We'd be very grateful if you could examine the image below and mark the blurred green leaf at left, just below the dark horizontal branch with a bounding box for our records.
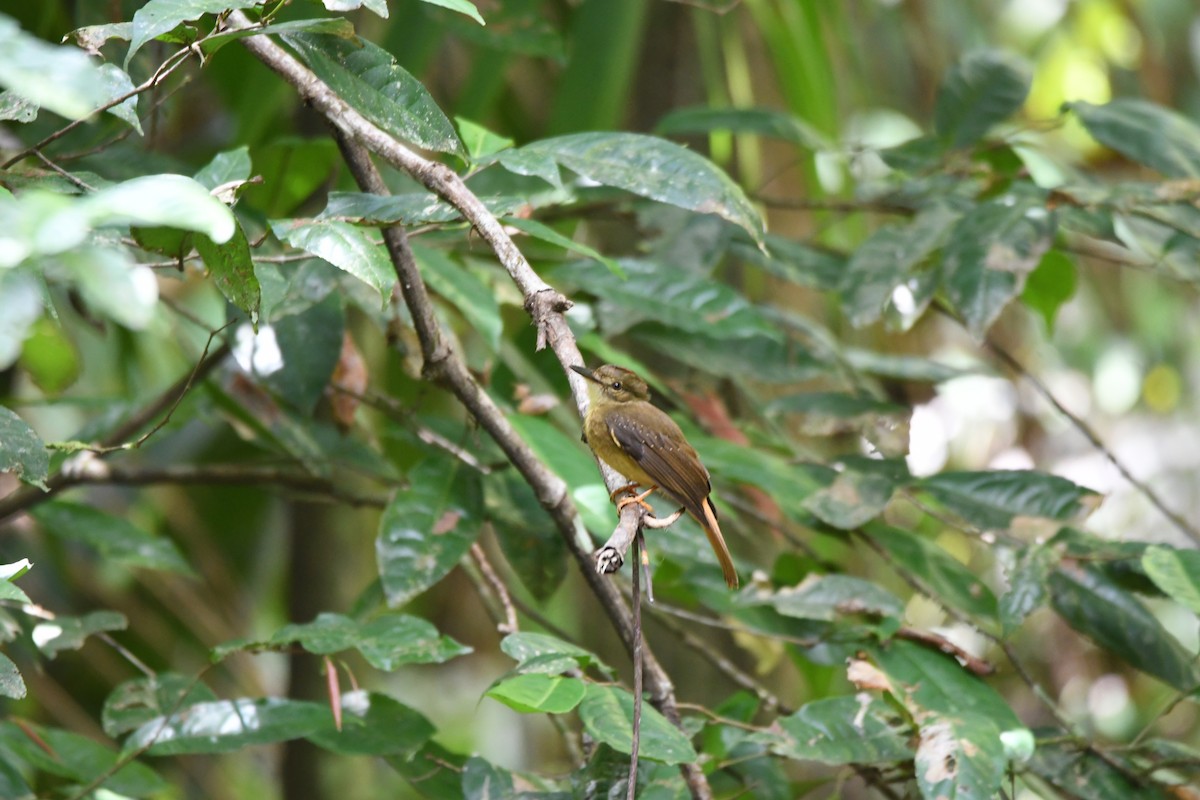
[30,500,193,575]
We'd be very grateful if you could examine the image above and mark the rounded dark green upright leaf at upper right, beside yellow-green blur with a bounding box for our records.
[934,50,1031,148]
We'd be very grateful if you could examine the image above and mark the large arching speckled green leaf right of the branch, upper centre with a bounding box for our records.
[499,133,766,243]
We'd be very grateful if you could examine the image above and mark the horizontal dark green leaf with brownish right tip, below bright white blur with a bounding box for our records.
[917,469,1099,529]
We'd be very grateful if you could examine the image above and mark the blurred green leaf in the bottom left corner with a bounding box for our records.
[0,722,170,798]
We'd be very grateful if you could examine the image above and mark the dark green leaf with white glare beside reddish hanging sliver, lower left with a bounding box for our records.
[308,690,437,756]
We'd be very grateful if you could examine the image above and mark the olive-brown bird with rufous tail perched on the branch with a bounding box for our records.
[571,363,738,589]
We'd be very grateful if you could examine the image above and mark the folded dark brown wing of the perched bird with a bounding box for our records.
[605,414,712,517]
